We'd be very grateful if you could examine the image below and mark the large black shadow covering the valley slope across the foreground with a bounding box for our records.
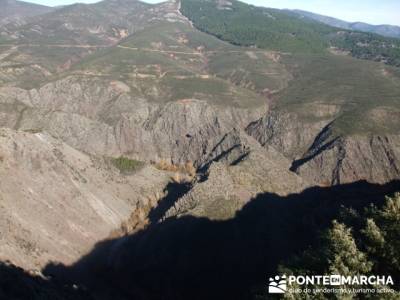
[9,181,400,300]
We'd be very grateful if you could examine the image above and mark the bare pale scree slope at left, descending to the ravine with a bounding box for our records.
[0,129,170,269]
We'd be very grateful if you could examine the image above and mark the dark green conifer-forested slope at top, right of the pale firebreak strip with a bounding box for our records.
[181,0,335,53]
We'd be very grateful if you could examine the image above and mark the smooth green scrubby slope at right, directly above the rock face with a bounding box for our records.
[275,55,400,135]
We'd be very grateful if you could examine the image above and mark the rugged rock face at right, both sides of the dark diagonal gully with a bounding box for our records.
[246,112,400,185]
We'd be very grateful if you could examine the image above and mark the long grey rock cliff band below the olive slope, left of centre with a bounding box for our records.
[0,77,265,164]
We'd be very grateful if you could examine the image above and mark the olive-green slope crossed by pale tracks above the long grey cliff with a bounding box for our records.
[71,22,290,107]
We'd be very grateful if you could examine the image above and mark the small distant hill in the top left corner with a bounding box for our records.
[0,0,53,25]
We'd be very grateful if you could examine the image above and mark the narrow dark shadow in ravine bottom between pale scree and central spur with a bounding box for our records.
[149,182,192,224]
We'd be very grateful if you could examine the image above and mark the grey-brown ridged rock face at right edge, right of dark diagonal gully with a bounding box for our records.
[292,131,400,185]
